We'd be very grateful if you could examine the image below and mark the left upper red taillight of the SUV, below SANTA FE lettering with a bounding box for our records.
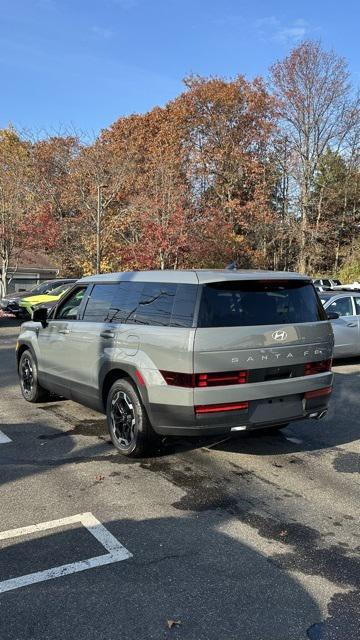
[160,371,248,388]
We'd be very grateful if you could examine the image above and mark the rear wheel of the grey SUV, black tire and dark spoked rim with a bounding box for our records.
[106,379,157,458]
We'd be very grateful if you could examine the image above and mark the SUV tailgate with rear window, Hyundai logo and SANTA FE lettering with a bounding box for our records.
[194,278,333,416]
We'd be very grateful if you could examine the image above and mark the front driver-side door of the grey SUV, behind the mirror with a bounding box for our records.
[37,285,87,397]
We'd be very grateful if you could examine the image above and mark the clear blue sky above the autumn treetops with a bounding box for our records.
[0,0,360,135]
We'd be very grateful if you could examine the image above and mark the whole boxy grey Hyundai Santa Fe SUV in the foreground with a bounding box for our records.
[17,270,333,456]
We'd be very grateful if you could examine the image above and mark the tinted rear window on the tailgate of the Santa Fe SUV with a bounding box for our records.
[198,280,327,327]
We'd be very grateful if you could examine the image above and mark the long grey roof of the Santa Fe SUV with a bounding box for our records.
[78,269,311,284]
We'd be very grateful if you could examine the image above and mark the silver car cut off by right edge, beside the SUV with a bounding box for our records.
[319,291,360,358]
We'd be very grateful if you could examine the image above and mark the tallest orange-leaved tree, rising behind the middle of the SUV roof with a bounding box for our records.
[179,76,276,266]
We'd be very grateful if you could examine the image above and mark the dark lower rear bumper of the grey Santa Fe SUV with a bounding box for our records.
[149,394,330,436]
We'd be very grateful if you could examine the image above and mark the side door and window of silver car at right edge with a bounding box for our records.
[326,295,359,358]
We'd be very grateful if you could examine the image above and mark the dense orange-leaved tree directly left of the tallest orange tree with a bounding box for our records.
[103,105,191,269]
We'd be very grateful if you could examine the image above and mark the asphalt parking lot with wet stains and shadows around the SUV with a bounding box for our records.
[0,320,360,640]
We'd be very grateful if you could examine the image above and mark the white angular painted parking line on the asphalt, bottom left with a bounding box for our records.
[0,513,132,593]
